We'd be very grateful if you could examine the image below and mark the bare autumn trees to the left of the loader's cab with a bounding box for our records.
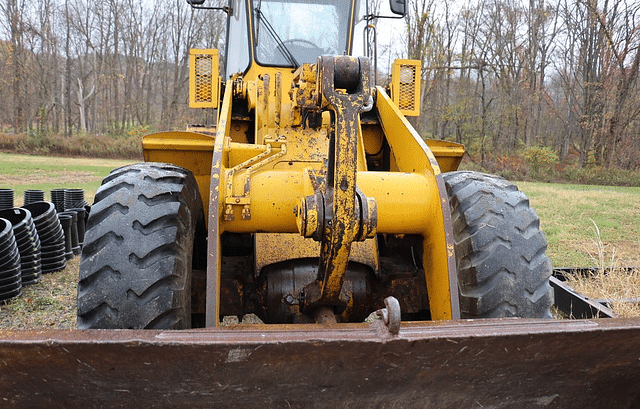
[0,0,225,135]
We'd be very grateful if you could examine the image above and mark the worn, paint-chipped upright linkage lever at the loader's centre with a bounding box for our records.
[312,55,377,304]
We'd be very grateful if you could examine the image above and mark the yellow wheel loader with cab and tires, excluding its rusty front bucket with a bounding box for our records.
[78,0,553,332]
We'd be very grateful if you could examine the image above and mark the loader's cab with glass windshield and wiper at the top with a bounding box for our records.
[188,0,405,78]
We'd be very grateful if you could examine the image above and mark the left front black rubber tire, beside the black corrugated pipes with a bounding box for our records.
[78,163,204,329]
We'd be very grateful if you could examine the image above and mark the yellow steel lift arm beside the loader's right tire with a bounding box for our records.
[376,87,459,320]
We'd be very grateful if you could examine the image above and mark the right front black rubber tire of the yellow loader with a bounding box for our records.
[443,171,553,318]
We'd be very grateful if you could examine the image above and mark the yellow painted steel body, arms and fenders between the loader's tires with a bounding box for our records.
[148,47,464,326]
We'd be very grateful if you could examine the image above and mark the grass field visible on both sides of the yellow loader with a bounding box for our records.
[0,153,640,329]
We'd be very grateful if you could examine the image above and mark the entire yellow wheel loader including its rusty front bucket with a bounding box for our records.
[0,0,640,408]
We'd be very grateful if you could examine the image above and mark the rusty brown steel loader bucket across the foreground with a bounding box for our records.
[0,319,640,408]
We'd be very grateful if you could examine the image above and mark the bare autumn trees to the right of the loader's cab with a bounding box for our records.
[405,0,640,169]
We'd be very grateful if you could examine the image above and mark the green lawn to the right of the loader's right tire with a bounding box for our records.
[517,182,640,267]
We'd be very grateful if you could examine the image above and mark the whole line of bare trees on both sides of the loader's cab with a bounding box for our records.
[0,0,640,169]
